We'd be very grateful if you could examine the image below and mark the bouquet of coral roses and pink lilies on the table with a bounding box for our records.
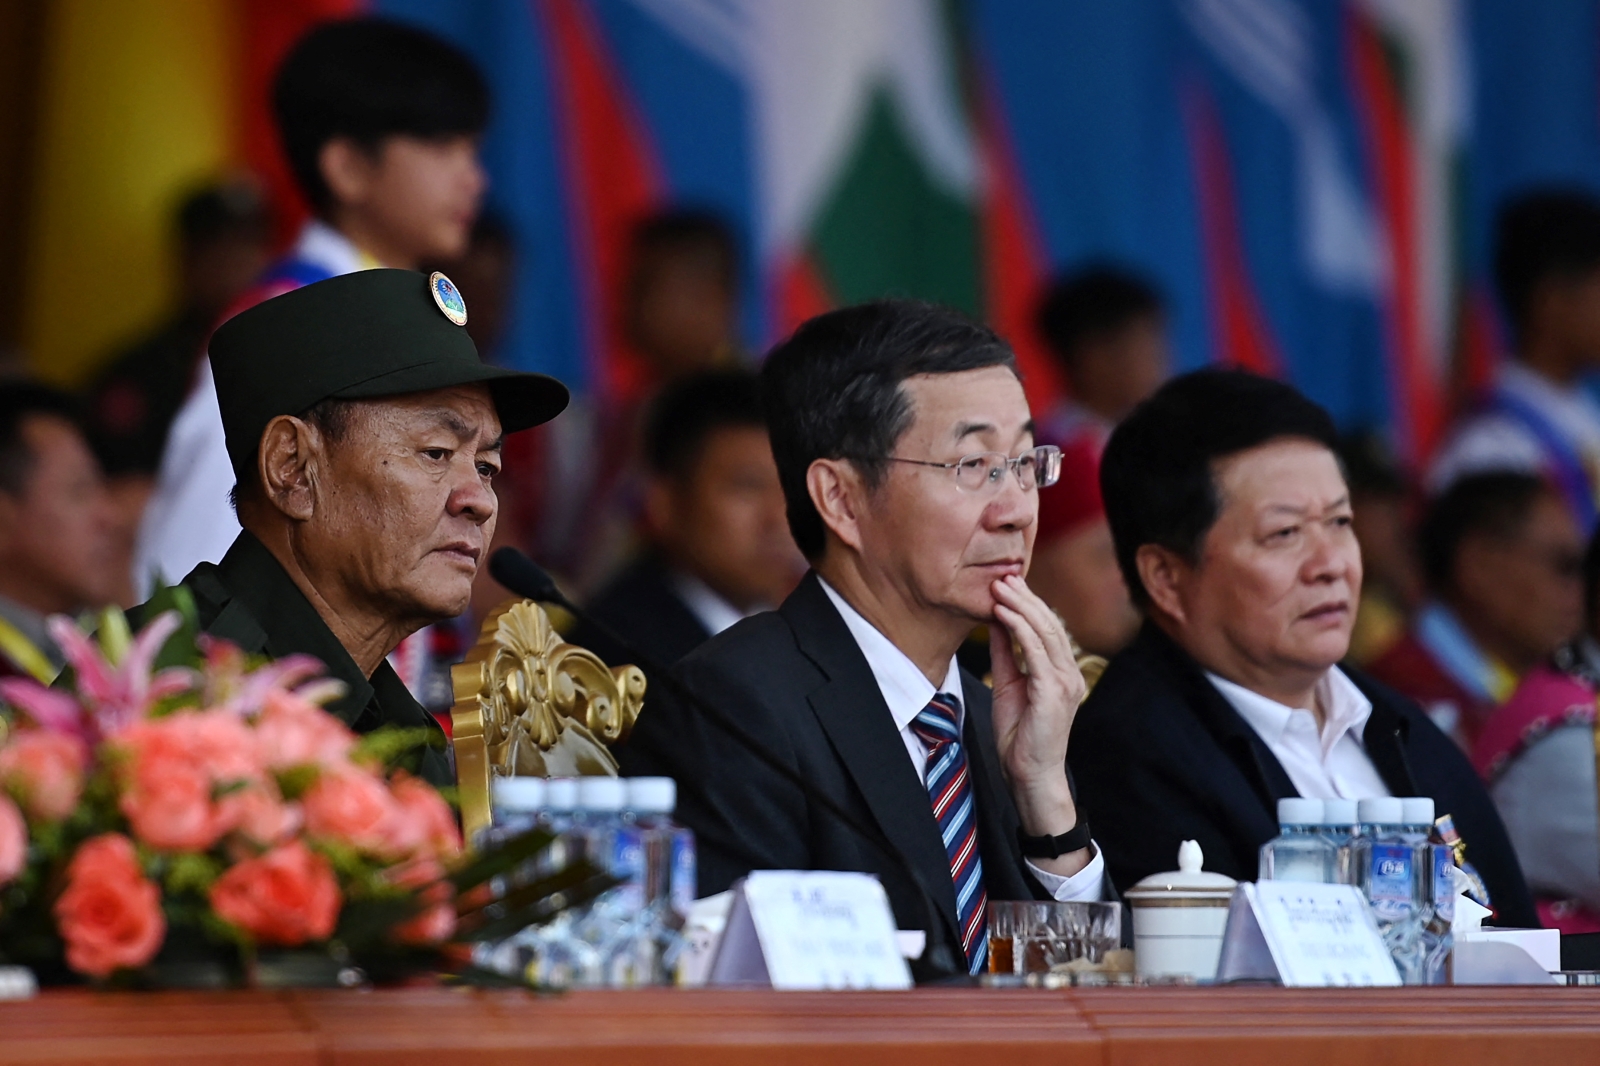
[0,595,474,981]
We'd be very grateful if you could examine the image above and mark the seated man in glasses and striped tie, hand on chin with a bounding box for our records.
[622,301,1104,973]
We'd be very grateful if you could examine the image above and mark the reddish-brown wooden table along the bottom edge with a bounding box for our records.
[0,988,1600,1066]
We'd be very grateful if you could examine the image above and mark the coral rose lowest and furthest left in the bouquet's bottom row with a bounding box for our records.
[54,832,166,978]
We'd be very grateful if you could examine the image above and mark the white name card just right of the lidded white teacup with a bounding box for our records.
[1216,880,1400,988]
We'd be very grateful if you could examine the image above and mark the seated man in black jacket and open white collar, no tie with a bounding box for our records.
[1069,370,1538,925]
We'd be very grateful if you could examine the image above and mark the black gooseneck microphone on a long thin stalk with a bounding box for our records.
[490,547,966,978]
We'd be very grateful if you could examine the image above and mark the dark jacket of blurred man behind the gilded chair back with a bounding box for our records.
[568,555,710,675]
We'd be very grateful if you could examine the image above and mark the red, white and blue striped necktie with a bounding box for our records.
[910,691,989,973]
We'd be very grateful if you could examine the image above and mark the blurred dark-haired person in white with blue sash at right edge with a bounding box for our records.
[1429,189,1600,536]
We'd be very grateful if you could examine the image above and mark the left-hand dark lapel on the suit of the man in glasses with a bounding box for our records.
[781,573,960,944]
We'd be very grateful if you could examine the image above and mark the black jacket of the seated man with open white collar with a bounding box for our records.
[1067,623,1539,927]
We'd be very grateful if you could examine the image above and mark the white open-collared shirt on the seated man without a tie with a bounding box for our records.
[1206,666,1389,800]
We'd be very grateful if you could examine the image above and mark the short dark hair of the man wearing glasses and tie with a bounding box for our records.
[762,299,1016,560]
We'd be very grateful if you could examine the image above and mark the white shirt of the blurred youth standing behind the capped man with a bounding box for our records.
[133,221,370,597]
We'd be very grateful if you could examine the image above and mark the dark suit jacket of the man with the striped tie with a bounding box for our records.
[621,573,1043,959]
